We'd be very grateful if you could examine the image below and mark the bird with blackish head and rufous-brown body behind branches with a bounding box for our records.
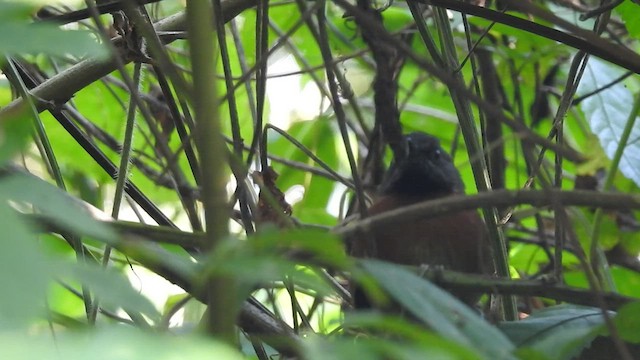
[349,132,494,309]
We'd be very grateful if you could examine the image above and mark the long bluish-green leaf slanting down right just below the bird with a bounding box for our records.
[362,260,515,359]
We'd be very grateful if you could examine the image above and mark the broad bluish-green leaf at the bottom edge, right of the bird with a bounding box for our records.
[500,305,604,360]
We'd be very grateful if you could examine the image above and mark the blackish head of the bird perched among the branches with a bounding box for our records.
[381,132,464,197]
